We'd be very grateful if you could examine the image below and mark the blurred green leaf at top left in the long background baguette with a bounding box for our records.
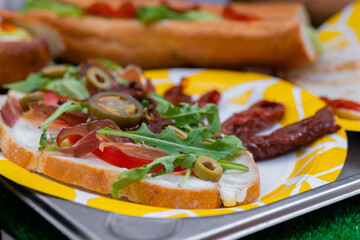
[22,0,84,17]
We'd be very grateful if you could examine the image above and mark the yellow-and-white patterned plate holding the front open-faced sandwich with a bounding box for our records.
[0,69,347,218]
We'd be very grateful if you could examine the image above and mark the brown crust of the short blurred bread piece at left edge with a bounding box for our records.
[0,38,50,85]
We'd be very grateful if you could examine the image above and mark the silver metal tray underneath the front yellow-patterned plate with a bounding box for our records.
[0,132,360,240]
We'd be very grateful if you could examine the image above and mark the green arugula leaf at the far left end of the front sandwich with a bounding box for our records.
[4,72,51,93]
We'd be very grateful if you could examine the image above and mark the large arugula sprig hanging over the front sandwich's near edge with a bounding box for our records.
[98,123,248,198]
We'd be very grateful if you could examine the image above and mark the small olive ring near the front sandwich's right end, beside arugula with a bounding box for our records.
[194,156,222,182]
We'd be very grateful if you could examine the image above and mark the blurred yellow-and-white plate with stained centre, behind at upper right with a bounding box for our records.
[287,1,360,131]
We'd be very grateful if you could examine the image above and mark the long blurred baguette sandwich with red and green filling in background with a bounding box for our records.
[21,0,319,69]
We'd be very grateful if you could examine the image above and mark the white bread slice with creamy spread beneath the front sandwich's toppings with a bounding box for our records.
[0,96,260,209]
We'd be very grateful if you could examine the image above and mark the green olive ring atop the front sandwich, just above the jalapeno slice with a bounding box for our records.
[86,67,111,90]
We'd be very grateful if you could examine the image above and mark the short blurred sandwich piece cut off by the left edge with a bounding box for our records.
[0,9,64,86]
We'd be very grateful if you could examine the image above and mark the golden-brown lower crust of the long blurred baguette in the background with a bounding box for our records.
[28,10,316,69]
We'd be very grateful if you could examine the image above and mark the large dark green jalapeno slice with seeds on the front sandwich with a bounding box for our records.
[89,92,144,128]
